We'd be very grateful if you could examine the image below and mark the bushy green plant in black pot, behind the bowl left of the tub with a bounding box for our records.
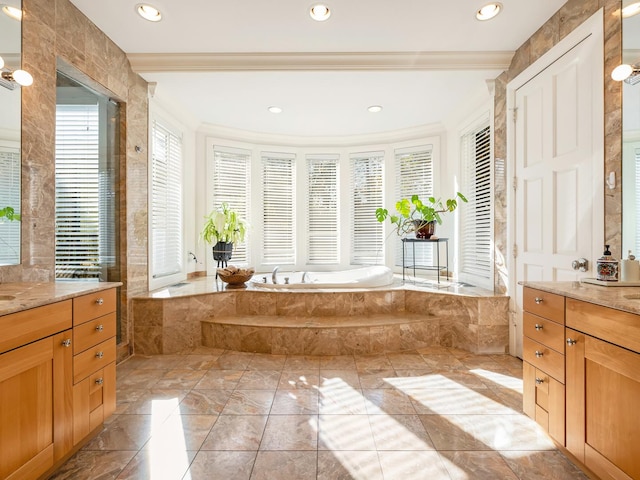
[200,202,247,266]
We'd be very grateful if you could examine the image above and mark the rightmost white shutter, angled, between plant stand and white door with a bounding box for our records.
[460,120,493,280]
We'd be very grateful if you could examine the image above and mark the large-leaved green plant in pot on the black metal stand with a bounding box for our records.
[376,192,467,238]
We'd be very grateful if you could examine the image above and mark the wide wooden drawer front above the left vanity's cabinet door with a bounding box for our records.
[0,300,71,353]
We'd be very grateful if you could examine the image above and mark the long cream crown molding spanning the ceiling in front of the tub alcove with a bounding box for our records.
[127,51,514,73]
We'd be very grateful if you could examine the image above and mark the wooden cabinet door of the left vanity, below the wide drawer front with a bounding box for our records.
[0,337,54,479]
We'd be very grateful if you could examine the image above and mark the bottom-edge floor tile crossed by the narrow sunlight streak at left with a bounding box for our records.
[117,448,196,480]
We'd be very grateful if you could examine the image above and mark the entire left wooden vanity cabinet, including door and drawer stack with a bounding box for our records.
[0,288,116,480]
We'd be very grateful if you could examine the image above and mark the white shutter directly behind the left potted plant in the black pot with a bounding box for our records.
[207,146,251,266]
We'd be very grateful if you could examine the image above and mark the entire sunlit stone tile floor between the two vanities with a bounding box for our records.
[51,347,586,480]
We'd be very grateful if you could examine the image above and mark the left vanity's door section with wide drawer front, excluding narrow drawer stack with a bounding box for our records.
[0,301,72,480]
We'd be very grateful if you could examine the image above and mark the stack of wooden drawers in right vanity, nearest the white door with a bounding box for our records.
[522,287,565,445]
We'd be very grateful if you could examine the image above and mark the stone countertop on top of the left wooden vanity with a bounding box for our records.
[0,282,122,315]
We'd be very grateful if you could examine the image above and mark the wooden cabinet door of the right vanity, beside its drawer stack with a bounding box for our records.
[567,330,640,479]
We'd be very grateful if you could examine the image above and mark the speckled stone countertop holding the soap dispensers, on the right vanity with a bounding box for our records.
[522,282,640,314]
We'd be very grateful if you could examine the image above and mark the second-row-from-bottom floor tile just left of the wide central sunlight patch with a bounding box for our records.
[260,415,318,451]
